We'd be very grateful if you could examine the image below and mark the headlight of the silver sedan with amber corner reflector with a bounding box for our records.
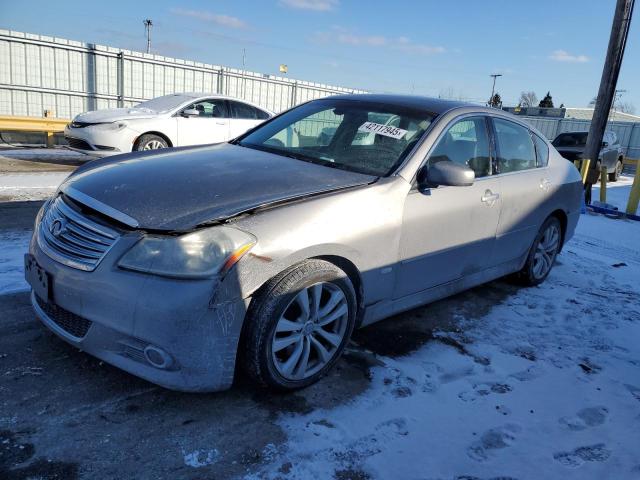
[118,226,256,278]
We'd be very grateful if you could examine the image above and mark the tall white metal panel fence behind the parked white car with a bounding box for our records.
[0,29,365,118]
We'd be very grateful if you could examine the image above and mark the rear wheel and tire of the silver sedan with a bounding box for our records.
[515,217,562,287]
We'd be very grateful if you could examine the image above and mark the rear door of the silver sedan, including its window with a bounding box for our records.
[492,117,557,264]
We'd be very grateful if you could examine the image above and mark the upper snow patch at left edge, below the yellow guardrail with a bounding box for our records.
[0,172,69,201]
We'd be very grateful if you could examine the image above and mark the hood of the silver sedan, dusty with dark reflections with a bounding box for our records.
[61,143,377,231]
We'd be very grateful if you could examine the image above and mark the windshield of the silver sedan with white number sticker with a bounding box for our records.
[236,99,434,176]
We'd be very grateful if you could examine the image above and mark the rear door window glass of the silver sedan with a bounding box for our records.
[493,118,537,173]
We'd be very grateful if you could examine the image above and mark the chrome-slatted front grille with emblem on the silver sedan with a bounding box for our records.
[37,196,120,271]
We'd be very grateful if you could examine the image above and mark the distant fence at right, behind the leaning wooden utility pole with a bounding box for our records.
[523,117,640,159]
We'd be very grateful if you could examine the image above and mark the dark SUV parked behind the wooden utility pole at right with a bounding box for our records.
[552,132,624,182]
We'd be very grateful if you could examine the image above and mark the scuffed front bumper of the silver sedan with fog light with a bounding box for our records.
[29,231,248,391]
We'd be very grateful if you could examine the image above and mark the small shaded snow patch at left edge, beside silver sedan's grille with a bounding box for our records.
[0,230,31,295]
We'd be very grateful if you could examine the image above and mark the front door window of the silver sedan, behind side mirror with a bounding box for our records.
[428,117,491,178]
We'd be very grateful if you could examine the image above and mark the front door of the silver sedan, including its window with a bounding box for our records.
[395,116,502,298]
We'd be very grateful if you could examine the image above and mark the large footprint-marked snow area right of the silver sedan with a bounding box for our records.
[251,215,640,480]
